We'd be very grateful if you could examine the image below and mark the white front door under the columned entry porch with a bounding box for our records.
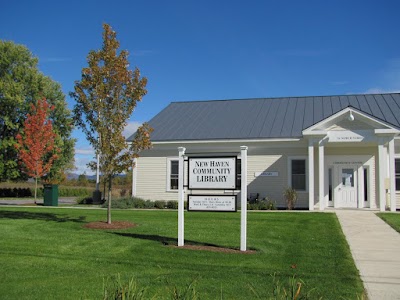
[337,165,358,208]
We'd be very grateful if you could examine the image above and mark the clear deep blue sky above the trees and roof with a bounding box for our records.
[0,0,400,173]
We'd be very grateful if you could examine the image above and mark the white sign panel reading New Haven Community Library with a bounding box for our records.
[189,157,236,190]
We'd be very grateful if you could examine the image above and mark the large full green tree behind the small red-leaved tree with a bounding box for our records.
[0,40,75,183]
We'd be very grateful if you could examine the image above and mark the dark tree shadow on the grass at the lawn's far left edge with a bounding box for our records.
[0,210,86,223]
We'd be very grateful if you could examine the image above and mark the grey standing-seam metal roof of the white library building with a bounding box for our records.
[128,93,400,141]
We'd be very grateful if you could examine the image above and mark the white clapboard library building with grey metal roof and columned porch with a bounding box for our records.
[128,93,400,211]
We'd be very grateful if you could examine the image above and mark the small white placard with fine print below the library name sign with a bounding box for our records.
[188,195,236,212]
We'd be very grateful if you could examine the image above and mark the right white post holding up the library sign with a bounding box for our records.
[240,146,248,251]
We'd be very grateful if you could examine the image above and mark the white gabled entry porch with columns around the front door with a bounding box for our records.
[303,108,399,211]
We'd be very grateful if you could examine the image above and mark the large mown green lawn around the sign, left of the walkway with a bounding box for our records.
[0,207,363,299]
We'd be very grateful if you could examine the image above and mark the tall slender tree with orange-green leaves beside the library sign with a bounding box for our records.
[70,24,152,224]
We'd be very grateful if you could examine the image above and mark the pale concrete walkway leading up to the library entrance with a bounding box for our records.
[336,210,400,300]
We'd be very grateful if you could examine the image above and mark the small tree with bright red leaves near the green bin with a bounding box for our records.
[15,99,60,203]
